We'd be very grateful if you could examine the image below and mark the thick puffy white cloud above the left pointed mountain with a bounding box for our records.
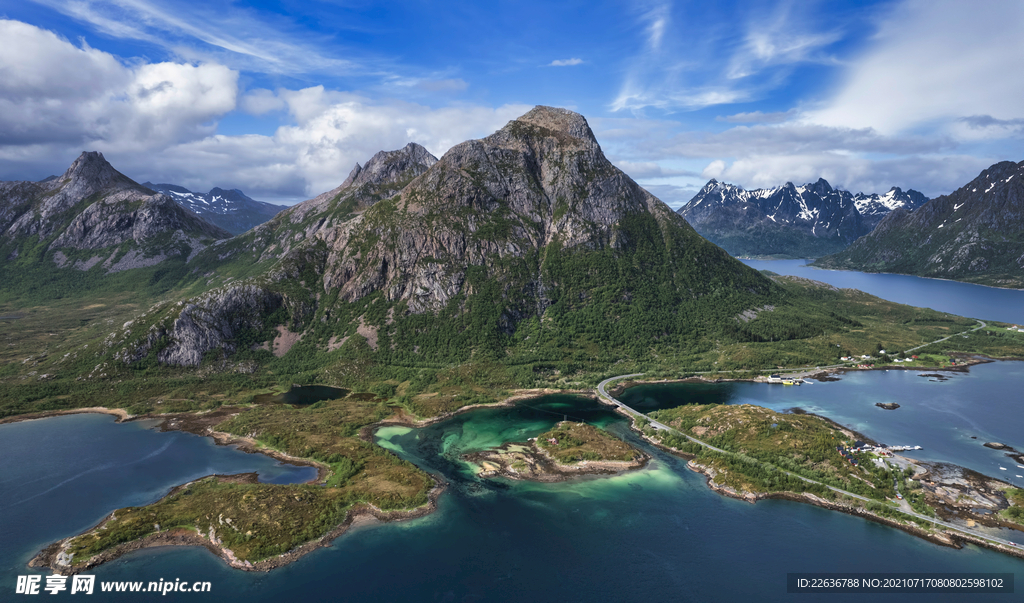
[0,20,238,153]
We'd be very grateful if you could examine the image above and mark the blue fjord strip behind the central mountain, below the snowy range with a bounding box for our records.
[742,260,1024,322]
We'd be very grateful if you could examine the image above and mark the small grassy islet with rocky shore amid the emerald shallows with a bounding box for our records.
[463,421,649,481]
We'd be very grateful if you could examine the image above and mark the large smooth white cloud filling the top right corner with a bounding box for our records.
[806,0,1024,134]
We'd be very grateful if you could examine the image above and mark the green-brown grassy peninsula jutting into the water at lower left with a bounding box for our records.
[61,394,434,561]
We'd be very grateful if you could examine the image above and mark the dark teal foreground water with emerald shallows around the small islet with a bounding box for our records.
[0,393,1024,602]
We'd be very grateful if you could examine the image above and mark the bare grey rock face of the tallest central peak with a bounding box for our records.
[318,106,686,312]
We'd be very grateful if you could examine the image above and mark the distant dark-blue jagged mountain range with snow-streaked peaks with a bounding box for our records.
[679,178,927,257]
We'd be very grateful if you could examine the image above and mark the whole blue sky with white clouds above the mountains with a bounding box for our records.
[0,0,1024,207]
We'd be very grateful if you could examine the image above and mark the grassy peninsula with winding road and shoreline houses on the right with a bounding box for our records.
[635,404,1024,547]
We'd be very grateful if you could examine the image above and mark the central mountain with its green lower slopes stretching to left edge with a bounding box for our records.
[0,106,1015,417]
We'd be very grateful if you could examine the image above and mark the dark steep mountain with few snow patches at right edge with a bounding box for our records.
[815,162,1024,288]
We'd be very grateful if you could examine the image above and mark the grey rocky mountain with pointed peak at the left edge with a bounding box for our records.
[0,153,230,286]
